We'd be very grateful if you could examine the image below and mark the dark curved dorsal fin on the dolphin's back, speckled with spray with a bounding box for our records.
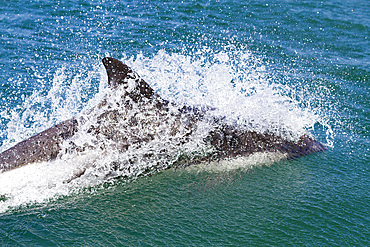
[102,57,160,100]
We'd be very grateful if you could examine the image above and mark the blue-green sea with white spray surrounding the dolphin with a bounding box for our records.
[0,0,370,246]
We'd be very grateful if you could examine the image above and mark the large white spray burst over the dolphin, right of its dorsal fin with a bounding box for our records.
[122,48,321,138]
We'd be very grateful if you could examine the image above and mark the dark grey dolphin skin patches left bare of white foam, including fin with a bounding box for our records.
[0,57,326,173]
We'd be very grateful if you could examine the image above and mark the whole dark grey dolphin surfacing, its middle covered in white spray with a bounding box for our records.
[0,57,326,172]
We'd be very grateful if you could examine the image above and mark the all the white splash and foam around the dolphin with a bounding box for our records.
[0,47,330,212]
